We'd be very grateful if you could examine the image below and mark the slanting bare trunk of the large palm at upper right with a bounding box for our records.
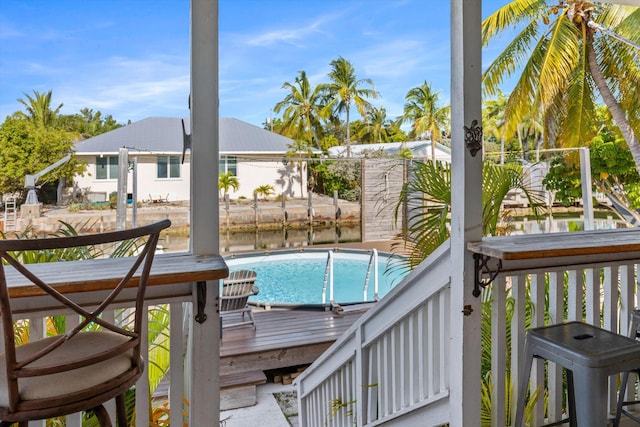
[587,42,640,173]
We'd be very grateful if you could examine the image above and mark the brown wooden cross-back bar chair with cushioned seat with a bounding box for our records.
[0,220,171,427]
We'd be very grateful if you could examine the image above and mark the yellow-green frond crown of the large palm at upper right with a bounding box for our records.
[482,0,640,171]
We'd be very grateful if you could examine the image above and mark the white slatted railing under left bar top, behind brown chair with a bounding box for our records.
[5,298,191,427]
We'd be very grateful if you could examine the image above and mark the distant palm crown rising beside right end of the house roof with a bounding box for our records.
[274,71,324,149]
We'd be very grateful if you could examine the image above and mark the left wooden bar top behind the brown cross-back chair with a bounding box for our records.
[5,253,229,298]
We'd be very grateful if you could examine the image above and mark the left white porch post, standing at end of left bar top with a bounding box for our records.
[190,0,220,426]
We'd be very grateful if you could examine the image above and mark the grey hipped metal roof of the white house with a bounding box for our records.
[75,117,293,155]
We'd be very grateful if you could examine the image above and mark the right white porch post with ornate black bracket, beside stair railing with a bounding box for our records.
[450,0,482,427]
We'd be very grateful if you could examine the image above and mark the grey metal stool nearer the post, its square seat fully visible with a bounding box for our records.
[515,322,640,427]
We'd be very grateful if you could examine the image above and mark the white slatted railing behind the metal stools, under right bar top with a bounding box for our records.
[483,260,640,426]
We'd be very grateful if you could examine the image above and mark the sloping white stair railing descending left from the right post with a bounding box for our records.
[296,244,450,427]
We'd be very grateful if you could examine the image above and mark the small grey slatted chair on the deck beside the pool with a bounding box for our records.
[220,270,259,336]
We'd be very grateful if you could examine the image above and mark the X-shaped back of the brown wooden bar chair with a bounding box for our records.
[0,220,171,412]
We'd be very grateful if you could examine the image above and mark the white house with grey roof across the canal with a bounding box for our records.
[75,117,306,201]
